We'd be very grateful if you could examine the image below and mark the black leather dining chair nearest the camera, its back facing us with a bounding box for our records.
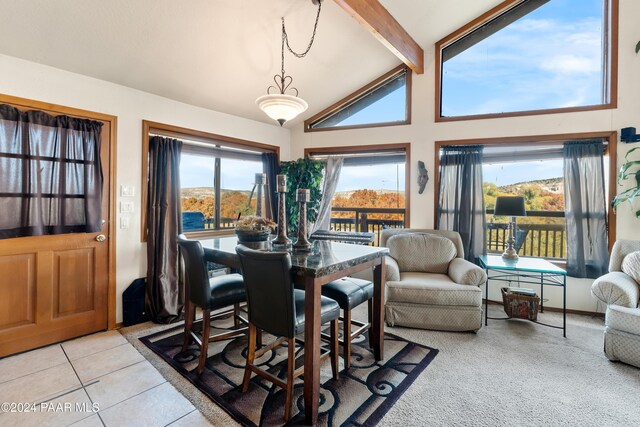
[236,245,340,421]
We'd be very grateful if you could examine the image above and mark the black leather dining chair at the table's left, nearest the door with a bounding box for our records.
[178,234,248,375]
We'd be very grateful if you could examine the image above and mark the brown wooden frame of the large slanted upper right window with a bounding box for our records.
[434,0,619,122]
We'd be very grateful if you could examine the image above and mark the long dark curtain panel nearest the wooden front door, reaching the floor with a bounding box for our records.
[146,136,184,323]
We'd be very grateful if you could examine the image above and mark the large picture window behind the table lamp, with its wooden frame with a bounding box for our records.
[436,132,617,262]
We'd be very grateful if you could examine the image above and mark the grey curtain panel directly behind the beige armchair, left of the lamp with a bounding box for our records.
[437,145,486,262]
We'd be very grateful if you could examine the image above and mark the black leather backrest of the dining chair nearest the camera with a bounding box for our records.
[236,245,296,338]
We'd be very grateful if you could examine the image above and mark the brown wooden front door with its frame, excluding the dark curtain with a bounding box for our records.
[0,96,115,357]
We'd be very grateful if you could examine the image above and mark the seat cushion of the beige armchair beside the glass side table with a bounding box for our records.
[386,272,482,307]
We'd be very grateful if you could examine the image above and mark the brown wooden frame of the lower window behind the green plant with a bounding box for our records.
[304,142,411,228]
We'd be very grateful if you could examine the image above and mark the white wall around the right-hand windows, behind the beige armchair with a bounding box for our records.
[291,0,640,311]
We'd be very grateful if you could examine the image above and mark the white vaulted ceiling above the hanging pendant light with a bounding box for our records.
[0,0,500,126]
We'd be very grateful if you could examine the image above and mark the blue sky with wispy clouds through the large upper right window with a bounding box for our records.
[442,0,602,116]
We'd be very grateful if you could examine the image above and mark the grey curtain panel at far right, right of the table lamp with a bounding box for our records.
[563,141,609,279]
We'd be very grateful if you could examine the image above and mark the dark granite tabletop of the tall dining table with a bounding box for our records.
[198,236,389,277]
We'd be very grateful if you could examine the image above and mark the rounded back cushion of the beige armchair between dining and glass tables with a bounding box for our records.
[387,233,458,274]
